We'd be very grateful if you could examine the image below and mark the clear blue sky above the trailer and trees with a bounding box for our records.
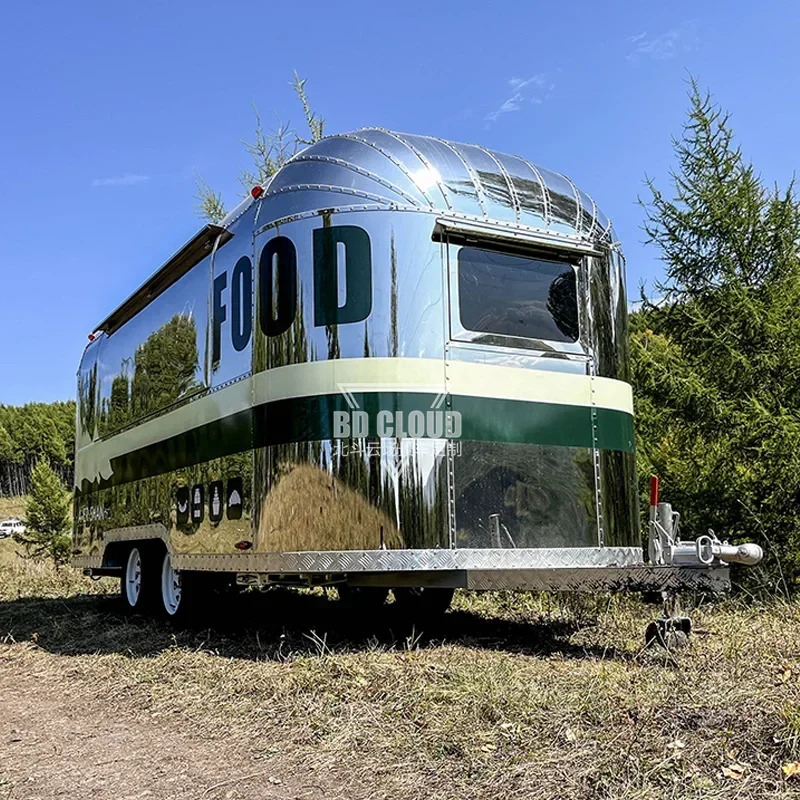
[0,0,800,404]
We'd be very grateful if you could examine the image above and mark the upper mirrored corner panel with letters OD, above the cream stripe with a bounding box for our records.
[253,209,445,371]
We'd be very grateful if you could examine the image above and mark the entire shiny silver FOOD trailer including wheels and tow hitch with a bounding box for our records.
[73,128,760,614]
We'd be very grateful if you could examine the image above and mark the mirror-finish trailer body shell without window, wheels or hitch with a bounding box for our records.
[76,129,638,555]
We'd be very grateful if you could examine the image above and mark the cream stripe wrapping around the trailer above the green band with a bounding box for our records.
[75,357,633,486]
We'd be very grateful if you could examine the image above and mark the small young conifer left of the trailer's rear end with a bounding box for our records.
[15,458,71,568]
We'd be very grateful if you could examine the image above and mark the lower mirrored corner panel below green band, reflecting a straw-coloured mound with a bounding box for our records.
[255,434,448,552]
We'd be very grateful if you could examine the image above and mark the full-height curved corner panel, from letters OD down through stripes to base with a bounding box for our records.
[253,209,449,552]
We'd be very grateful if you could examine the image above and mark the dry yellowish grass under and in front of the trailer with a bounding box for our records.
[0,543,800,800]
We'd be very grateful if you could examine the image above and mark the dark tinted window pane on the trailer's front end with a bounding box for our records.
[458,247,578,342]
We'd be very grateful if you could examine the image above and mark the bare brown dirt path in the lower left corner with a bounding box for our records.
[0,657,324,800]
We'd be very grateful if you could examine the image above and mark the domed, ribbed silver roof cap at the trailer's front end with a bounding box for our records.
[265,128,611,242]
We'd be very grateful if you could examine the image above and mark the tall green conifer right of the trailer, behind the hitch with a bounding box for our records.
[631,82,800,583]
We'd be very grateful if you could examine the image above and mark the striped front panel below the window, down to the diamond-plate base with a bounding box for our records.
[446,354,598,547]
